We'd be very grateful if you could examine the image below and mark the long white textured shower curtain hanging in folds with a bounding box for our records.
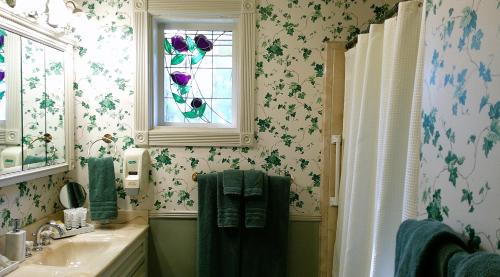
[333,1,423,277]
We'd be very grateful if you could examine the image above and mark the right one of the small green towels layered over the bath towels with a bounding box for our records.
[244,170,268,228]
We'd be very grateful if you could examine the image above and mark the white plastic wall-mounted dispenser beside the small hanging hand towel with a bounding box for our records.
[123,148,150,196]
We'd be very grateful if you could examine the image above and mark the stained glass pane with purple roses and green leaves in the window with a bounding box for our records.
[163,29,235,126]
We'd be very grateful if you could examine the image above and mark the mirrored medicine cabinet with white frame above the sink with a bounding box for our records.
[0,8,73,187]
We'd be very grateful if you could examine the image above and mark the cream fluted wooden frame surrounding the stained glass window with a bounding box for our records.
[133,0,256,147]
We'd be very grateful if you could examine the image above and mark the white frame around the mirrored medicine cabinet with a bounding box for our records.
[0,7,75,187]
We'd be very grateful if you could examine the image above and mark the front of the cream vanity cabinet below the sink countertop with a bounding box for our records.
[99,230,148,277]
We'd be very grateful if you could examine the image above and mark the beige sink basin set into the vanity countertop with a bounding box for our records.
[33,241,112,268]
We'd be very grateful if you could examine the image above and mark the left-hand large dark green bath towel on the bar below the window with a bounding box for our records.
[197,173,241,277]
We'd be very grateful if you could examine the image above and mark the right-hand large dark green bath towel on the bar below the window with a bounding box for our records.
[241,176,290,277]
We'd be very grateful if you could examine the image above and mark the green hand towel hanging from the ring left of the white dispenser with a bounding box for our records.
[88,157,118,220]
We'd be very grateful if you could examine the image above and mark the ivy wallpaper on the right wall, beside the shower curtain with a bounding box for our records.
[419,0,500,253]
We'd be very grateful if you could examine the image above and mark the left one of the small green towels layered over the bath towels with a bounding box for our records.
[217,172,241,228]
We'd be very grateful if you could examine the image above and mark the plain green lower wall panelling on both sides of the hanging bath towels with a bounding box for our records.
[148,218,319,277]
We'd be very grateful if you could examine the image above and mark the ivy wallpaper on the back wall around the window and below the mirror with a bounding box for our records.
[1,0,397,231]
